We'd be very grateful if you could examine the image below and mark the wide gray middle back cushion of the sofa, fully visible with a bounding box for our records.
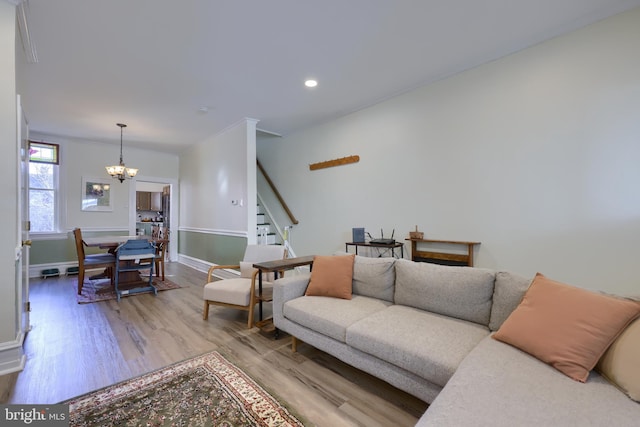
[394,259,495,326]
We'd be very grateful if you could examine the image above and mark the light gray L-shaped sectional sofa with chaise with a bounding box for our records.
[273,256,640,426]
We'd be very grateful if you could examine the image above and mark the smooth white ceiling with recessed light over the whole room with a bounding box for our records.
[17,0,640,153]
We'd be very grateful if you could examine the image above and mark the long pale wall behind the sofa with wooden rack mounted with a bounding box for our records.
[258,9,640,294]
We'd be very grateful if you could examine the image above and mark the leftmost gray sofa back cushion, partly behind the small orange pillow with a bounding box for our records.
[353,255,396,302]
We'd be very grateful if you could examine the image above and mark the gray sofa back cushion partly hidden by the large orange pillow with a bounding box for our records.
[489,271,531,331]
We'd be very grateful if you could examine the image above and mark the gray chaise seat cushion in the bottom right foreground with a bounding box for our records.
[417,338,640,427]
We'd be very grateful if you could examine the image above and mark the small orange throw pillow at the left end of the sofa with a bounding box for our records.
[305,254,355,299]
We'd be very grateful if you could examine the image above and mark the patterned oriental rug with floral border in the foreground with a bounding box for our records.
[62,351,304,427]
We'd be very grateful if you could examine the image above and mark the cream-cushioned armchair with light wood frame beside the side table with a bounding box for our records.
[202,245,286,329]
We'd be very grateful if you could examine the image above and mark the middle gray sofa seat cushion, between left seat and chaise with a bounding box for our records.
[347,305,489,386]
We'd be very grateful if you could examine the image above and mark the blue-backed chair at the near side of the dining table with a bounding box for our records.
[115,239,158,301]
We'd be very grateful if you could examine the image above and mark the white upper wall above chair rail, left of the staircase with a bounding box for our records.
[180,119,256,237]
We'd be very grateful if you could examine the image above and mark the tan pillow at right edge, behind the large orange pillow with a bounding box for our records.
[596,319,640,402]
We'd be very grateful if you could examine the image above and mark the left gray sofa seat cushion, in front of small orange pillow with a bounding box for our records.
[283,295,391,342]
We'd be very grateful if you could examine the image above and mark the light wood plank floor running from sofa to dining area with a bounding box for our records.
[8,263,427,427]
